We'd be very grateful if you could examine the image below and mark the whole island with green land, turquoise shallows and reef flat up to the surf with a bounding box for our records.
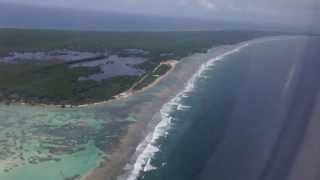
[0,29,284,180]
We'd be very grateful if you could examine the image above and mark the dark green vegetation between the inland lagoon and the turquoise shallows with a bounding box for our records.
[0,63,137,104]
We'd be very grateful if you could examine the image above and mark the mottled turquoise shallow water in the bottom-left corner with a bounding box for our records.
[0,105,112,180]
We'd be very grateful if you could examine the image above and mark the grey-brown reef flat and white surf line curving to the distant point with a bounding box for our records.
[83,36,304,180]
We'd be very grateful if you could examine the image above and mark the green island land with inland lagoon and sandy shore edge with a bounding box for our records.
[0,29,272,107]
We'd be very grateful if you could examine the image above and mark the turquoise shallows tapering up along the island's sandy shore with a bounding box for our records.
[0,40,231,180]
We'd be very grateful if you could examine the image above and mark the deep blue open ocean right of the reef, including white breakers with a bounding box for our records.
[127,37,320,180]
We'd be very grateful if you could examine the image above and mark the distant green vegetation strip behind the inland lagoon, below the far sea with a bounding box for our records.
[0,29,276,57]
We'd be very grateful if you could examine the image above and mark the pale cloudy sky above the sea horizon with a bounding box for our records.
[0,0,320,23]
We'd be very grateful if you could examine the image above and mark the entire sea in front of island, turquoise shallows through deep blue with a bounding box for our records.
[0,36,320,180]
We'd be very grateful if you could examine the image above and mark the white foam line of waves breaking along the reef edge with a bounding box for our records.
[126,43,249,180]
